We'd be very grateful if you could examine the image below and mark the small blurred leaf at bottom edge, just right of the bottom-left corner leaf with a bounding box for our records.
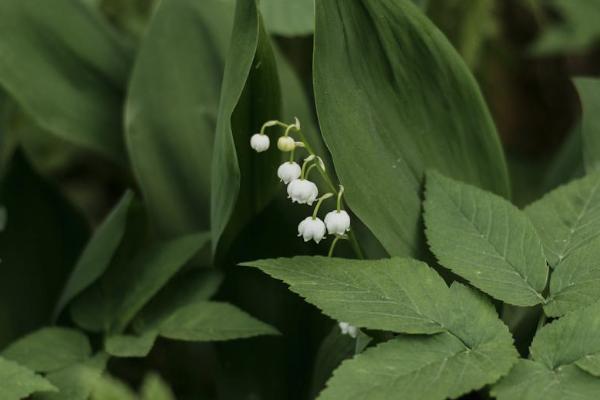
[33,353,108,400]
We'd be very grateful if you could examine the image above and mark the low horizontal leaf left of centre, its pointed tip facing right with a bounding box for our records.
[158,301,279,342]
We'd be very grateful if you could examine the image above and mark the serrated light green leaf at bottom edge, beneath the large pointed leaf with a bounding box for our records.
[319,331,517,400]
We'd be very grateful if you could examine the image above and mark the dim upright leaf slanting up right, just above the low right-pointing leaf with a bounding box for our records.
[71,233,209,333]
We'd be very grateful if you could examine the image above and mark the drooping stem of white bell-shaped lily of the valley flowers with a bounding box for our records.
[250,118,350,255]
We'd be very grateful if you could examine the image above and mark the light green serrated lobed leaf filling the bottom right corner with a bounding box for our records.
[492,303,600,400]
